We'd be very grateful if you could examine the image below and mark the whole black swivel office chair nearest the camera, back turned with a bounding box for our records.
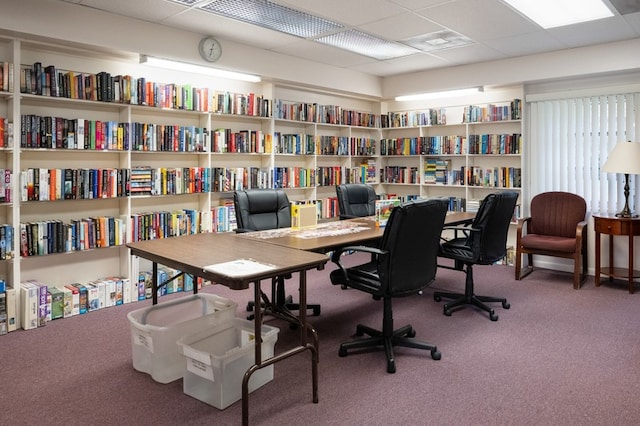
[330,199,447,373]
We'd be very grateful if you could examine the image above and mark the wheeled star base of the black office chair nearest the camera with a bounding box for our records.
[338,324,442,373]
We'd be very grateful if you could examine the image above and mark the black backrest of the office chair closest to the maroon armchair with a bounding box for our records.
[469,191,518,264]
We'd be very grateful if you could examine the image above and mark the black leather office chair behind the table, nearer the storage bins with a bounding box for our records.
[233,189,320,325]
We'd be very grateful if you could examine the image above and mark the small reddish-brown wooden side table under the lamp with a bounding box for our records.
[593,213,640,293]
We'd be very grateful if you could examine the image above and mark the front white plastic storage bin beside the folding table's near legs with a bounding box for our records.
[178,318,280,410]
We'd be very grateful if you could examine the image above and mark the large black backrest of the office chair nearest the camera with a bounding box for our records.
[378,199,448,296]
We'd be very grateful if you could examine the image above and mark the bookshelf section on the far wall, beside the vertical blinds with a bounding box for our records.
[380,95,523,208]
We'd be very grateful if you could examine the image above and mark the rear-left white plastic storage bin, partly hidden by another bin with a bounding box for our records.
[127,294,238,383]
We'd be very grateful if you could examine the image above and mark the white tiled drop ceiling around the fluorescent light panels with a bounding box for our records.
[55,0,640,77]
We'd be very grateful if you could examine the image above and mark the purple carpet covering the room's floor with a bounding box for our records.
[0,256,640,426]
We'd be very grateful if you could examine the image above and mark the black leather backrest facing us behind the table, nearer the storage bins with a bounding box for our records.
[233,189,291,231]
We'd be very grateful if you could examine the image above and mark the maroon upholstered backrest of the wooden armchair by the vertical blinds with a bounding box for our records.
[527,191,587,238]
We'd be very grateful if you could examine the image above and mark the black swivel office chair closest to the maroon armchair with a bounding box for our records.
[433,191,518,321]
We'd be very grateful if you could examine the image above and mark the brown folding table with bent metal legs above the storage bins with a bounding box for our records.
[127,233,328,425]
